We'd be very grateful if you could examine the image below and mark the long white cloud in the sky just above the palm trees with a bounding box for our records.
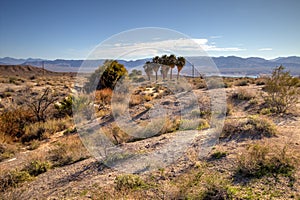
[90,38,245,59]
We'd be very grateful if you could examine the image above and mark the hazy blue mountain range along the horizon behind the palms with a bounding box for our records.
[0,56,300,76]
